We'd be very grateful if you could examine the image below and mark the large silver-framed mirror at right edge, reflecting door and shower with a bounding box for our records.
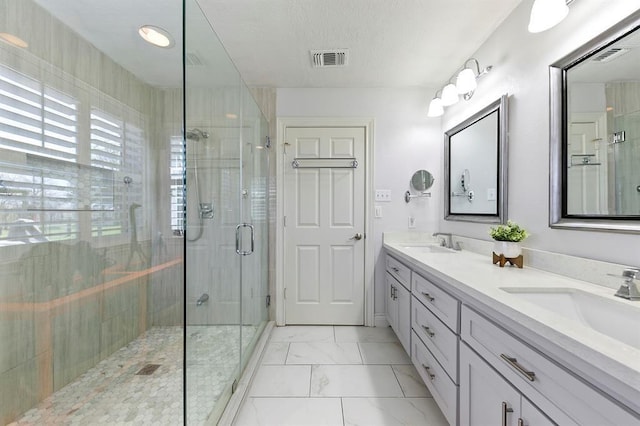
[549,11,640,233]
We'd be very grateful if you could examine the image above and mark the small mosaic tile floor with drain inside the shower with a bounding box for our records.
[11,326,256,426]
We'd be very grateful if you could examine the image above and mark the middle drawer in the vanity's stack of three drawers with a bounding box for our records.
[411,296,458,383]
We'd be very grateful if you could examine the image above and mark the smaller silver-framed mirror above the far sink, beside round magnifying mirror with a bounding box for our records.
[444,94,508,223]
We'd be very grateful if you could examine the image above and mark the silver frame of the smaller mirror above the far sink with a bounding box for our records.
[443,94,509,223]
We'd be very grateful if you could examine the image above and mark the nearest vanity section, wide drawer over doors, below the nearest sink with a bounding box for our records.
[460,306,640,426]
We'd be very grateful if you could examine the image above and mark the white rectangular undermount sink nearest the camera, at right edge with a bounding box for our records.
[501,287,640,349]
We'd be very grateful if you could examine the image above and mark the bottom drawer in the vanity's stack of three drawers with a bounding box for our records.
[411,332,458,425]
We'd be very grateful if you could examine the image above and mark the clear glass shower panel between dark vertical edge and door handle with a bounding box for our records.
[184,0,243,425]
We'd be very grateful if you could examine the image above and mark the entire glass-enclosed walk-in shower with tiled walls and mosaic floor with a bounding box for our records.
[0,0,269,426]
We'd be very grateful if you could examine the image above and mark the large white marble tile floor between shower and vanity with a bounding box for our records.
[234,326,448,426]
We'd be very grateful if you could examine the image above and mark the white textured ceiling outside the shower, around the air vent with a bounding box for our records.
[198,0,529,87]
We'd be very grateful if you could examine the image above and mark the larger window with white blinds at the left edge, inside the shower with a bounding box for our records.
[0,65,80,242]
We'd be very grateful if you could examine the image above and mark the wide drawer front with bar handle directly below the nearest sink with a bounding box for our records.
[461,306,640,426]
